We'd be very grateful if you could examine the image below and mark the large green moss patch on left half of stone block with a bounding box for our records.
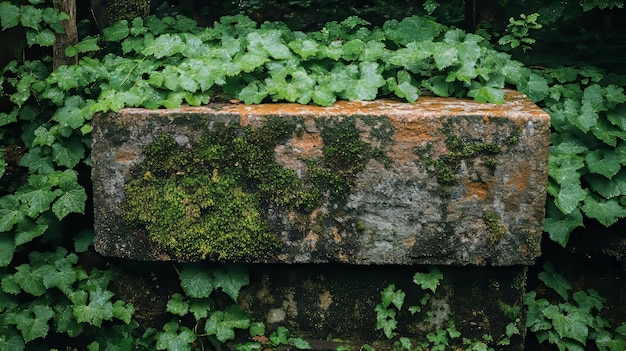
[124,117,390,261]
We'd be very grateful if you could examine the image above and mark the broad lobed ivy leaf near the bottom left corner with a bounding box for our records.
[7,305,54,342]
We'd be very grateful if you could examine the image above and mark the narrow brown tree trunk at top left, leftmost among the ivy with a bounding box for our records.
[52,0,78,69]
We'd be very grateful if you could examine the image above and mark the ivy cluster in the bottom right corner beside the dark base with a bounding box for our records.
[524,263,626,351]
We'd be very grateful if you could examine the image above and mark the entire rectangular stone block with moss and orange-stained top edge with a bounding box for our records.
[92,92,550,265]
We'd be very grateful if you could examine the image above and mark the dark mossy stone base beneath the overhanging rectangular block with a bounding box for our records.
[239,264,526,350]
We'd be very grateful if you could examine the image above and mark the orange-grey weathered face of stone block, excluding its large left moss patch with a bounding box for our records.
[92,91,550,266]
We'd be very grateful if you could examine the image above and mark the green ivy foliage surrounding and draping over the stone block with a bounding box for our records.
[0,0,626,350]
